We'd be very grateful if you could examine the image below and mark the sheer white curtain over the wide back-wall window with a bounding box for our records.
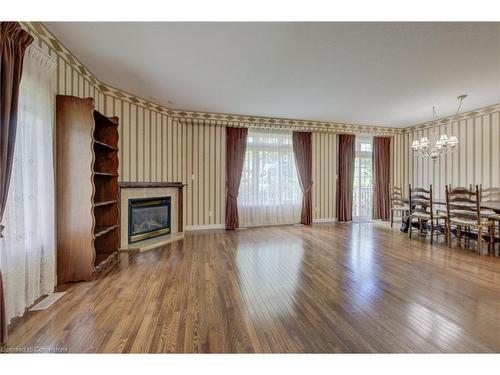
[238,129,302,227]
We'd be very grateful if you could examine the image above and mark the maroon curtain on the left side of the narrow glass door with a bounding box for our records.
[337,134,356,222]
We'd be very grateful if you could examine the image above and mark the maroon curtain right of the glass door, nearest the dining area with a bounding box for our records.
[372,137,391,220]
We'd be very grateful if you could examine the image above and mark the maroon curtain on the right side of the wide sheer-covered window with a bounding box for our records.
[292,132,312,225]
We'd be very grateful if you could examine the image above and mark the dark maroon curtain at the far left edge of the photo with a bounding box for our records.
[0,22,33,343]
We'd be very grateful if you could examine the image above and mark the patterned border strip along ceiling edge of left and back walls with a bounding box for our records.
[21,22,404,135]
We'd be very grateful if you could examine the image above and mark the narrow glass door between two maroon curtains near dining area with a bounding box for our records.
[352,136,373,221]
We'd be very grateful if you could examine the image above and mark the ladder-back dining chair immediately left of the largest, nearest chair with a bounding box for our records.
[408,185,446,244]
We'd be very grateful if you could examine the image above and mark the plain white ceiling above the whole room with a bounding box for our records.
[45,22,500,127]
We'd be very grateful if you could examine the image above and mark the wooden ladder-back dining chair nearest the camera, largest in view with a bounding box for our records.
[446,185,494,255]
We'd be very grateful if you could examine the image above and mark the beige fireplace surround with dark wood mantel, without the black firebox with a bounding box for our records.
[119,182,185,251]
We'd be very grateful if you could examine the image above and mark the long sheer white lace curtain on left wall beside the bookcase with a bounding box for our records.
[0,46,56,322]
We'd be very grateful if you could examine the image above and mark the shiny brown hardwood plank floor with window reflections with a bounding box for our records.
[7,223,500,353]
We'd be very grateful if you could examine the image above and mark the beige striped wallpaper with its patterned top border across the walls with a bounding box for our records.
[22,23,492,229]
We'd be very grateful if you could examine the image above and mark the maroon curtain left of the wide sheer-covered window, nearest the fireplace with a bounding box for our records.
[226,128,248,230]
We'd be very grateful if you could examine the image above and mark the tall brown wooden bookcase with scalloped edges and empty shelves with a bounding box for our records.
[56,95,120,284]
